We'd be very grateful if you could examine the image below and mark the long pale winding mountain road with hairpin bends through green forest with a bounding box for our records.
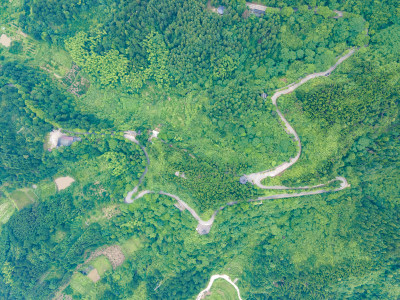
[64,49,355,234]
